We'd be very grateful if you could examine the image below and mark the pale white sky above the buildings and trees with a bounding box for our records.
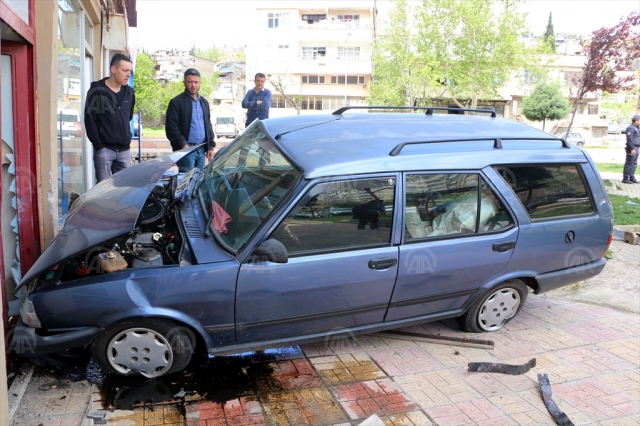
[136,0,640,51]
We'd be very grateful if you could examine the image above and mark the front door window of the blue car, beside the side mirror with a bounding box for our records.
[271,176,395,255]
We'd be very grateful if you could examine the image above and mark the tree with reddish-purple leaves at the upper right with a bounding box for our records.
[567,12,640,132]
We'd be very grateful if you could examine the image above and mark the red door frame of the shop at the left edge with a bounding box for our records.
[0,41,40,332]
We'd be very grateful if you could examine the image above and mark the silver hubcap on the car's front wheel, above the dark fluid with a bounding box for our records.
[107,328,173,377]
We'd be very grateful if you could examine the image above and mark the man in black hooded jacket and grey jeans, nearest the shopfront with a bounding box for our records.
[84,53,136,182]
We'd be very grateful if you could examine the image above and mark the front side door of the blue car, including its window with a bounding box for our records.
[236,174,398,343]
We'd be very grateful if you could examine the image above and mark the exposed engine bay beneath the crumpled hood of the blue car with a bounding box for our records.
[40,176,184,285]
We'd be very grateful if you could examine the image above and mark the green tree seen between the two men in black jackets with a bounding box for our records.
[133,51,166,120]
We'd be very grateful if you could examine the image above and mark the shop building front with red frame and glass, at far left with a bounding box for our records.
[0,0,137,412]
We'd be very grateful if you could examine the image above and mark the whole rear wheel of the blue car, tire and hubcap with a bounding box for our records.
[456,279,528,333]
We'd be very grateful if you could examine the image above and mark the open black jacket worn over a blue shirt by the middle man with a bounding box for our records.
[164,90,216,151]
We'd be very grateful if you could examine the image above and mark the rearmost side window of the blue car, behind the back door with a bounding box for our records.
[494,164,593,220]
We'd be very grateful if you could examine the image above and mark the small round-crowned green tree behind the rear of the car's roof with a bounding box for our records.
[522,83,571,130]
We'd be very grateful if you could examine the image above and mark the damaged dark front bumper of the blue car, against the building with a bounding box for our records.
[10,319,101,357]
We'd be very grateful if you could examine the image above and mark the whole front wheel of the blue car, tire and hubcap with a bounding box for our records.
[91,318,196,378]
